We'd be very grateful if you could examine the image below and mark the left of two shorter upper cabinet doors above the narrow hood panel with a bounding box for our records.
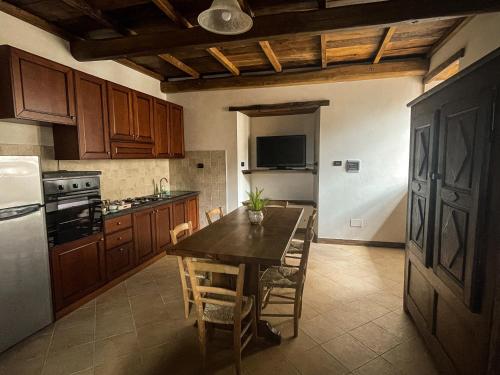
[108,82,135,141]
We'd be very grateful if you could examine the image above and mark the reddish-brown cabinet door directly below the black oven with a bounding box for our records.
[50,234,106,311]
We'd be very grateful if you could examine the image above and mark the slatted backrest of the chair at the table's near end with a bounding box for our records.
[186,258,245,322]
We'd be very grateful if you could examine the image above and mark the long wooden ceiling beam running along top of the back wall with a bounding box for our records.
[161,59,429,93]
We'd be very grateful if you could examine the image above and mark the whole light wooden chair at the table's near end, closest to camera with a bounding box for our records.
[186,258,257,375]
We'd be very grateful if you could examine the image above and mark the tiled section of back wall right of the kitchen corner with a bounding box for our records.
[170,151,226,226]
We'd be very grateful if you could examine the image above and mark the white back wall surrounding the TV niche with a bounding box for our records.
[168,77,422,242]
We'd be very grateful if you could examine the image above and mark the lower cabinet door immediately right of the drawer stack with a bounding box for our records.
[133,208,156,263]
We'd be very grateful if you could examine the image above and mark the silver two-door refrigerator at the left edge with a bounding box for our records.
[0,156,53,352]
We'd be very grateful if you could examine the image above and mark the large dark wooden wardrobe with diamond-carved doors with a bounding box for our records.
[404,49,500,375]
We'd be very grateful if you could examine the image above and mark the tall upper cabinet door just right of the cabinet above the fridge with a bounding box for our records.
[75,72,111,159]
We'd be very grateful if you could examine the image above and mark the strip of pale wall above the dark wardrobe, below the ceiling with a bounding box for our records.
[430,12,500,74]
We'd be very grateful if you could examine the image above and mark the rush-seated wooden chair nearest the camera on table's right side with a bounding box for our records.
[258,215,314,337]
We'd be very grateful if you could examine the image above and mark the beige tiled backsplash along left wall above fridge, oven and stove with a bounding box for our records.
[0,144,169,199]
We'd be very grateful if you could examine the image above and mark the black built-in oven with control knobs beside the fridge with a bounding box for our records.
[43,171,102,248]
